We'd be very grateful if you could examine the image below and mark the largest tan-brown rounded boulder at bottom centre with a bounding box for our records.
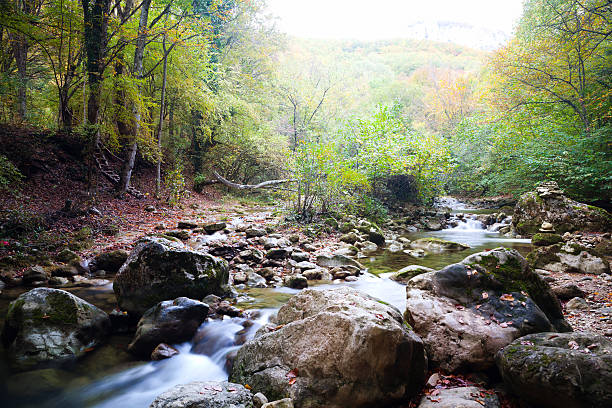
[230,287,427,407]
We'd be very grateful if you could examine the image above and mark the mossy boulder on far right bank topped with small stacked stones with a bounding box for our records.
[512,182,612,236]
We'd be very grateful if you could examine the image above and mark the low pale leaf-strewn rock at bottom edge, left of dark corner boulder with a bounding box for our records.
[417,387,500,408]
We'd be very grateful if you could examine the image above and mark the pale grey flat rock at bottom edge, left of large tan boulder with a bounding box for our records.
[149,381,253,408]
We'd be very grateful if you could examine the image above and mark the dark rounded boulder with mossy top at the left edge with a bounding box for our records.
[2,288,111,368]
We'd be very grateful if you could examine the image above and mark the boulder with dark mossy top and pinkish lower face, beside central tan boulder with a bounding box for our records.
[406,248,571,371]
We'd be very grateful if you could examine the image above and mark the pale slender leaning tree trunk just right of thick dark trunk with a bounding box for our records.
[119,0,151,193]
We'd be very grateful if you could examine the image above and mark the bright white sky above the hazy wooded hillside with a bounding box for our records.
[267,0,522,40]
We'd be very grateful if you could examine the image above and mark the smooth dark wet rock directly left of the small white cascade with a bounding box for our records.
[128,297,208,358]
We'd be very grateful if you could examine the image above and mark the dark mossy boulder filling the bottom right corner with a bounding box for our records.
[495,333,612,408]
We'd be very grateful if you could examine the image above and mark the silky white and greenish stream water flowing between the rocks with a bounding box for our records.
[0,199,530,408]
